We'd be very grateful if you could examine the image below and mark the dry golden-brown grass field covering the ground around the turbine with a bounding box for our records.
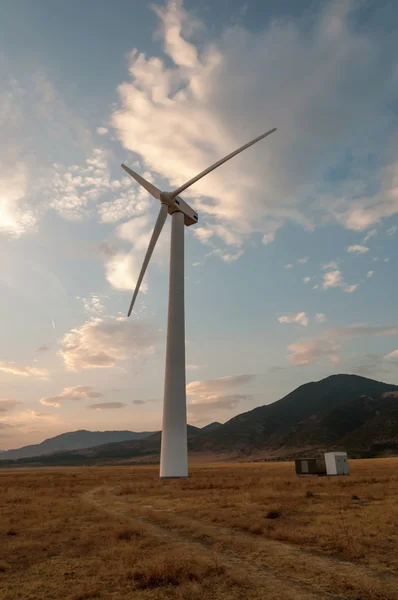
[0,459,398,600]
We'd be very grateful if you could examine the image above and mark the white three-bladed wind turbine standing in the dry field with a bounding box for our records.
[122,128,276,478]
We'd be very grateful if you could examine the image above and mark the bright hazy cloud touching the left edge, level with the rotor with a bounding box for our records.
[0,69,90,238]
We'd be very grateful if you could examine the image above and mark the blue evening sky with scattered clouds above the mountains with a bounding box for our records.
[0,0,398,449]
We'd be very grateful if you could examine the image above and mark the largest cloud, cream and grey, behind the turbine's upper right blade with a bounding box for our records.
[111,0,397,243]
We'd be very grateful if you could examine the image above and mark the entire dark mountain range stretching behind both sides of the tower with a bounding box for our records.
[0,375,398,466]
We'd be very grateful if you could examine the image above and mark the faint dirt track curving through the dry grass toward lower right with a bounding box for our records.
[83,487,398,600]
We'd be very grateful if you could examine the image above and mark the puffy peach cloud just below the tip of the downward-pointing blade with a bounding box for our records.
[59,317,157,371]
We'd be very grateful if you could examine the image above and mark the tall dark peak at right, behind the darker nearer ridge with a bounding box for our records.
[191,375,398,456]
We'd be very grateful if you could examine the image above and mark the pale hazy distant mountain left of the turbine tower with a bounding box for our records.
[0,429,152,460]
